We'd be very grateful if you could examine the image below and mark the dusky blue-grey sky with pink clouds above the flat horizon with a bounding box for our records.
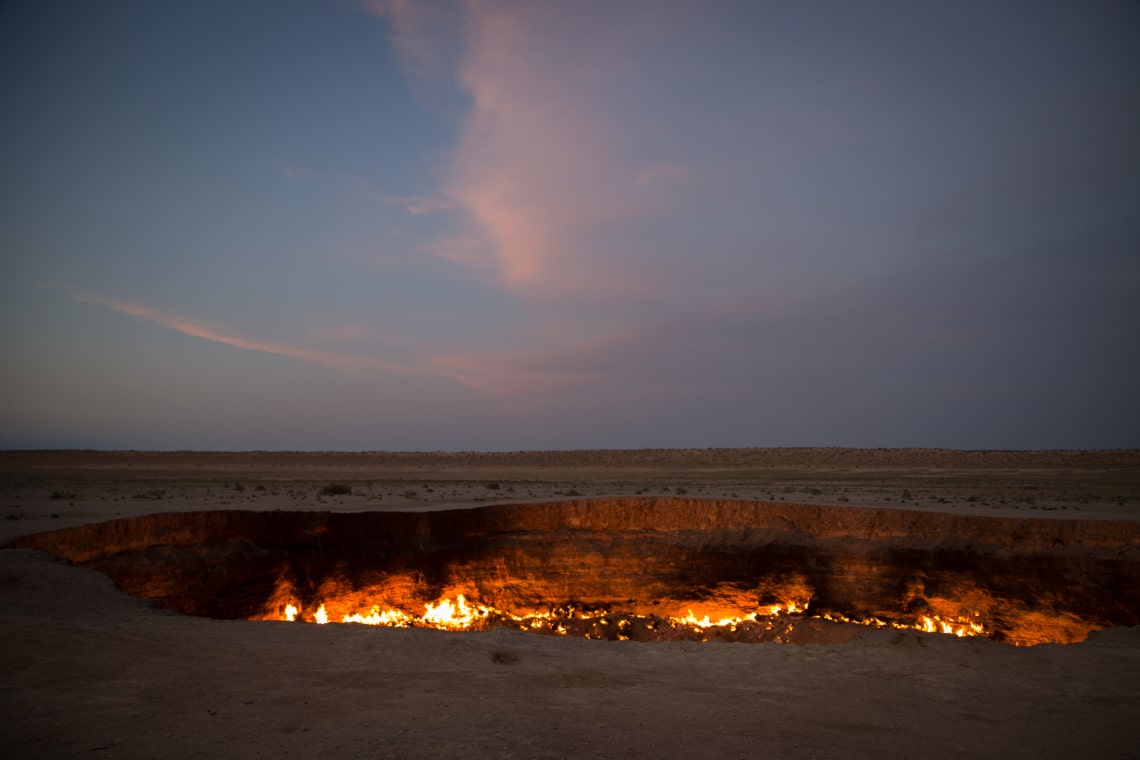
[0,0,1140,450]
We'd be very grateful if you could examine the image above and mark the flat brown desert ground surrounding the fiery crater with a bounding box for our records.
[0,449,1140,759]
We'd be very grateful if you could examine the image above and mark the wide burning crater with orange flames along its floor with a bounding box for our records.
[11,498,1140,645]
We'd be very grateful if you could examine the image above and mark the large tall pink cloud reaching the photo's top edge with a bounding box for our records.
[449,2,665,295]
